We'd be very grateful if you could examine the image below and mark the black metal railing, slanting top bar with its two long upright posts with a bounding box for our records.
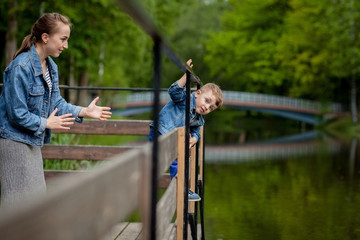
[119,0,204,239]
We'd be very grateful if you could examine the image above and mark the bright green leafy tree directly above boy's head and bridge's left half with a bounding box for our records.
[205,0,289,93]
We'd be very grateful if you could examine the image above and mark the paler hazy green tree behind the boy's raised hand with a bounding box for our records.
[163,1,227,87]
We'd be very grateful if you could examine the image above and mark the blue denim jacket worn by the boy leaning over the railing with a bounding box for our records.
[150,82,205,140]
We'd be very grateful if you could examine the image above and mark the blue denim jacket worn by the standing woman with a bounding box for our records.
[0,45,82,147]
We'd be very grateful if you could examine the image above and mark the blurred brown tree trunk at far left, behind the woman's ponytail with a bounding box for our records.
[5,0,18,66]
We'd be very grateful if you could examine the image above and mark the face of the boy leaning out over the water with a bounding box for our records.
[195,90,217,115]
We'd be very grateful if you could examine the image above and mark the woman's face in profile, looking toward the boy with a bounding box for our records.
[46,22,70,57]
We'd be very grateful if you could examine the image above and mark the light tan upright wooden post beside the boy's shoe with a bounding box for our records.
[176,127,185,239]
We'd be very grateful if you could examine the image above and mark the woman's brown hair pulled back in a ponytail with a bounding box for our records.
[13,13,71,59]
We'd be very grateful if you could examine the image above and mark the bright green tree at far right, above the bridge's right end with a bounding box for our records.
[276,0,359,103]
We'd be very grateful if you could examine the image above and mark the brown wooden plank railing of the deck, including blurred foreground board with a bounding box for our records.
[0,120,202,240]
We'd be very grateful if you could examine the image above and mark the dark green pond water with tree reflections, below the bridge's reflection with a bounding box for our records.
[204,139,360,240]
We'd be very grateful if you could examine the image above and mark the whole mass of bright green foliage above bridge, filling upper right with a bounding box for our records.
[205,0,360,102]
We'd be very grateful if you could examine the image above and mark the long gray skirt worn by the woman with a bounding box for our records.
[0,137,46,207]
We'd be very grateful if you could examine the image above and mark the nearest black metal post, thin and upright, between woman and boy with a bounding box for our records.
[150,37,161,240]
